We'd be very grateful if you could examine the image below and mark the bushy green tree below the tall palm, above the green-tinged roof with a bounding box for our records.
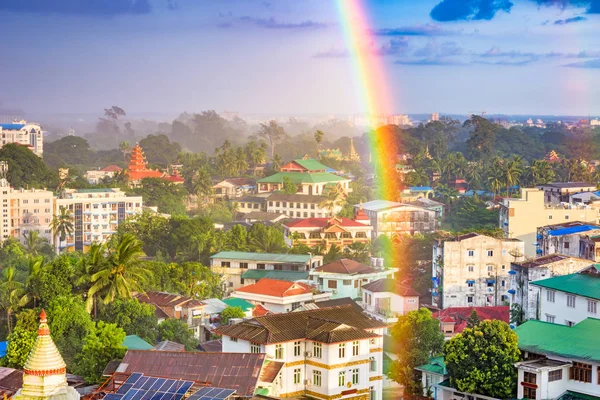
[98,299,158,343]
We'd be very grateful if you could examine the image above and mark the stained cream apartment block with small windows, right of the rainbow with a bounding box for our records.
[432,233,523,308]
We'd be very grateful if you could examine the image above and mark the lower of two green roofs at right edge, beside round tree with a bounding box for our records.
[515,318,600,362]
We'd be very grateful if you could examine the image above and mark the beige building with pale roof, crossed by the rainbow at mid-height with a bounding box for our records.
[354,200,439,240]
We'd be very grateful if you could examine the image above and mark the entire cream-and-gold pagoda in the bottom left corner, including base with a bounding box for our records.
[13,310,80,400]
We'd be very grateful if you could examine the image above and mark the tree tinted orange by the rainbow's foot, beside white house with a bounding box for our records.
[388,308,444,395]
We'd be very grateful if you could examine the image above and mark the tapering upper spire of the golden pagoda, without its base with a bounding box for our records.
[23,310,67,376]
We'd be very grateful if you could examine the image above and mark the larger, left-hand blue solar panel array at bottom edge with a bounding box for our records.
[104,373,194,400]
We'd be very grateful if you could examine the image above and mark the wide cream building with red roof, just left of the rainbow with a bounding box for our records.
[283,211,373,249]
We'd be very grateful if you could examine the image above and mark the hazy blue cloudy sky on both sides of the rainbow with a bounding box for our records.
[0,0,600,116]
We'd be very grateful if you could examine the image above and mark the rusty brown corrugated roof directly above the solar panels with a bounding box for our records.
[121,350,265,397]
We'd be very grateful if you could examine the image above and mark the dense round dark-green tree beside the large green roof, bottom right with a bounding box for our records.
[444,320,521,398]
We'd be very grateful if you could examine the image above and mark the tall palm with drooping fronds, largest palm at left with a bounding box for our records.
[86,233,152,312]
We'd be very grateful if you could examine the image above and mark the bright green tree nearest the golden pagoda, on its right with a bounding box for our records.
[73,321,127,384]
